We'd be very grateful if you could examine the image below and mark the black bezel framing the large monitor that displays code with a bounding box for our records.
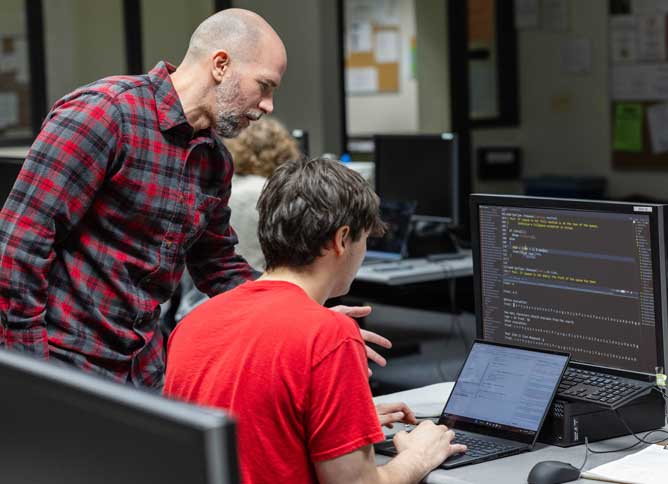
[469,193,668,379]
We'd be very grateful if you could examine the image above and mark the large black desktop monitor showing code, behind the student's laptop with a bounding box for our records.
[471,194,668,375]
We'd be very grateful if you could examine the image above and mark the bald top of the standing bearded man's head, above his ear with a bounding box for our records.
[183,8,283,63]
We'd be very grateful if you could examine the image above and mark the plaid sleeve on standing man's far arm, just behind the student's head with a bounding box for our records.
[186,181,260,297]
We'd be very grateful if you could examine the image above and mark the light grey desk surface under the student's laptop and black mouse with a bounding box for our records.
[374,382,668,484]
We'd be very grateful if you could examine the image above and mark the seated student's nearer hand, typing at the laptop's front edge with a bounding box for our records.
[393,420,466,469]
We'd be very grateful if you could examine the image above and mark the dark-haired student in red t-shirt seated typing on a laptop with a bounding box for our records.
[164,159,465,484]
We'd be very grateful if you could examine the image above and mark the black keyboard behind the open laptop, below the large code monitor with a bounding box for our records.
[557,367,654,410]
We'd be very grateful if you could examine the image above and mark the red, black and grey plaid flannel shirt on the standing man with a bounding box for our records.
[0,62,255,387]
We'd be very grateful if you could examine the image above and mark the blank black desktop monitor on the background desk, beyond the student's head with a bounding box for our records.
[374,133,459,224]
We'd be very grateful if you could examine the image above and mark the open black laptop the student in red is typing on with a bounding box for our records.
[375,340,570,469]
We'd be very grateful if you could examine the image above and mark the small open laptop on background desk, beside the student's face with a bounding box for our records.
[364,200,417,264]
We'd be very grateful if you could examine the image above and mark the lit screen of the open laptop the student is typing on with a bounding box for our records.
[441,341,569,440]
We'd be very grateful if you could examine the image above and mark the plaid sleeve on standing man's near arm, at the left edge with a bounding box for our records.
[0,93,121,358]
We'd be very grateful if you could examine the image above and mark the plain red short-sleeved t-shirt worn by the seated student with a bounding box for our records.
[164,281,383,484]
